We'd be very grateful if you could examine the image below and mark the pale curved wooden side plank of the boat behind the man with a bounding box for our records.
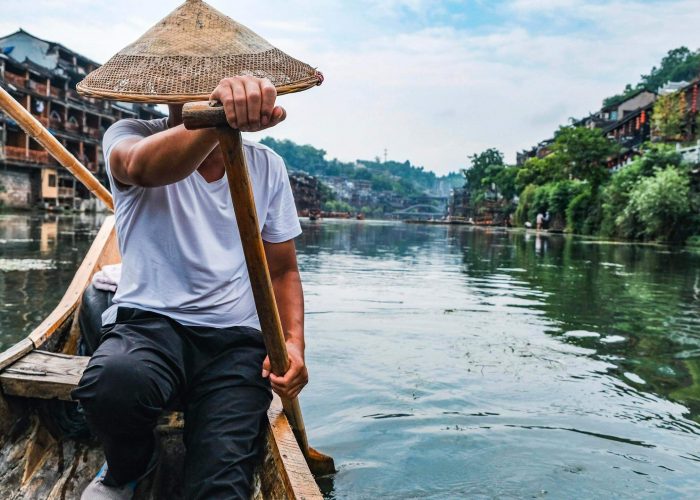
[28,216,119,348]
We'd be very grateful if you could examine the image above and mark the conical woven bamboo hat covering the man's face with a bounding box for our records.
[77,0,323,104]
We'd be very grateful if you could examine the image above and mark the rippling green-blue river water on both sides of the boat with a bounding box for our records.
[0,215,700,499]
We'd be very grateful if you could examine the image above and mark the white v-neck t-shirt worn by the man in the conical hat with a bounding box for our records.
[102,118,301,329]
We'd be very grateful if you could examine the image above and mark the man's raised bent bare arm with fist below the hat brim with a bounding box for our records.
[109,76,286,187]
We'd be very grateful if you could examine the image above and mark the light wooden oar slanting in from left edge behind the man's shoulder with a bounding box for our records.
[0,87,114,211]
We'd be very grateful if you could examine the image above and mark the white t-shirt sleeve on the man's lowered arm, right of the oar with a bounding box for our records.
[262,155,301,243]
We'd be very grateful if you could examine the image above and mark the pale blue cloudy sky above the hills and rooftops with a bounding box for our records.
[0,0,700,174]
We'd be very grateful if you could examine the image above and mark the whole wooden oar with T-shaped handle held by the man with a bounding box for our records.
[182,101,335,475]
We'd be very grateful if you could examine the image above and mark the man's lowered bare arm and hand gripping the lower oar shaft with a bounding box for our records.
[263,240,309,398]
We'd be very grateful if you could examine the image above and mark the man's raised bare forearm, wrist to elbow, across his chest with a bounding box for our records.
[125,125,218,187]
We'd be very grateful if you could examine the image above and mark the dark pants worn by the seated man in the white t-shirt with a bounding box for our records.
[73,308,272,499]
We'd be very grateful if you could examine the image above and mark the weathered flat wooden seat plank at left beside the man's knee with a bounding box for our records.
[0,351,90,401]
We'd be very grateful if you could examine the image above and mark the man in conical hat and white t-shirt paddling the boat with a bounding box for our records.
[73,0,316,500]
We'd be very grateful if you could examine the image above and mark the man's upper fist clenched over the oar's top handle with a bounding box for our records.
[210,76,287,132]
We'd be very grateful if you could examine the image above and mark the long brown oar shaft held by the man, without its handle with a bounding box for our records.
[217,126,309,455]
